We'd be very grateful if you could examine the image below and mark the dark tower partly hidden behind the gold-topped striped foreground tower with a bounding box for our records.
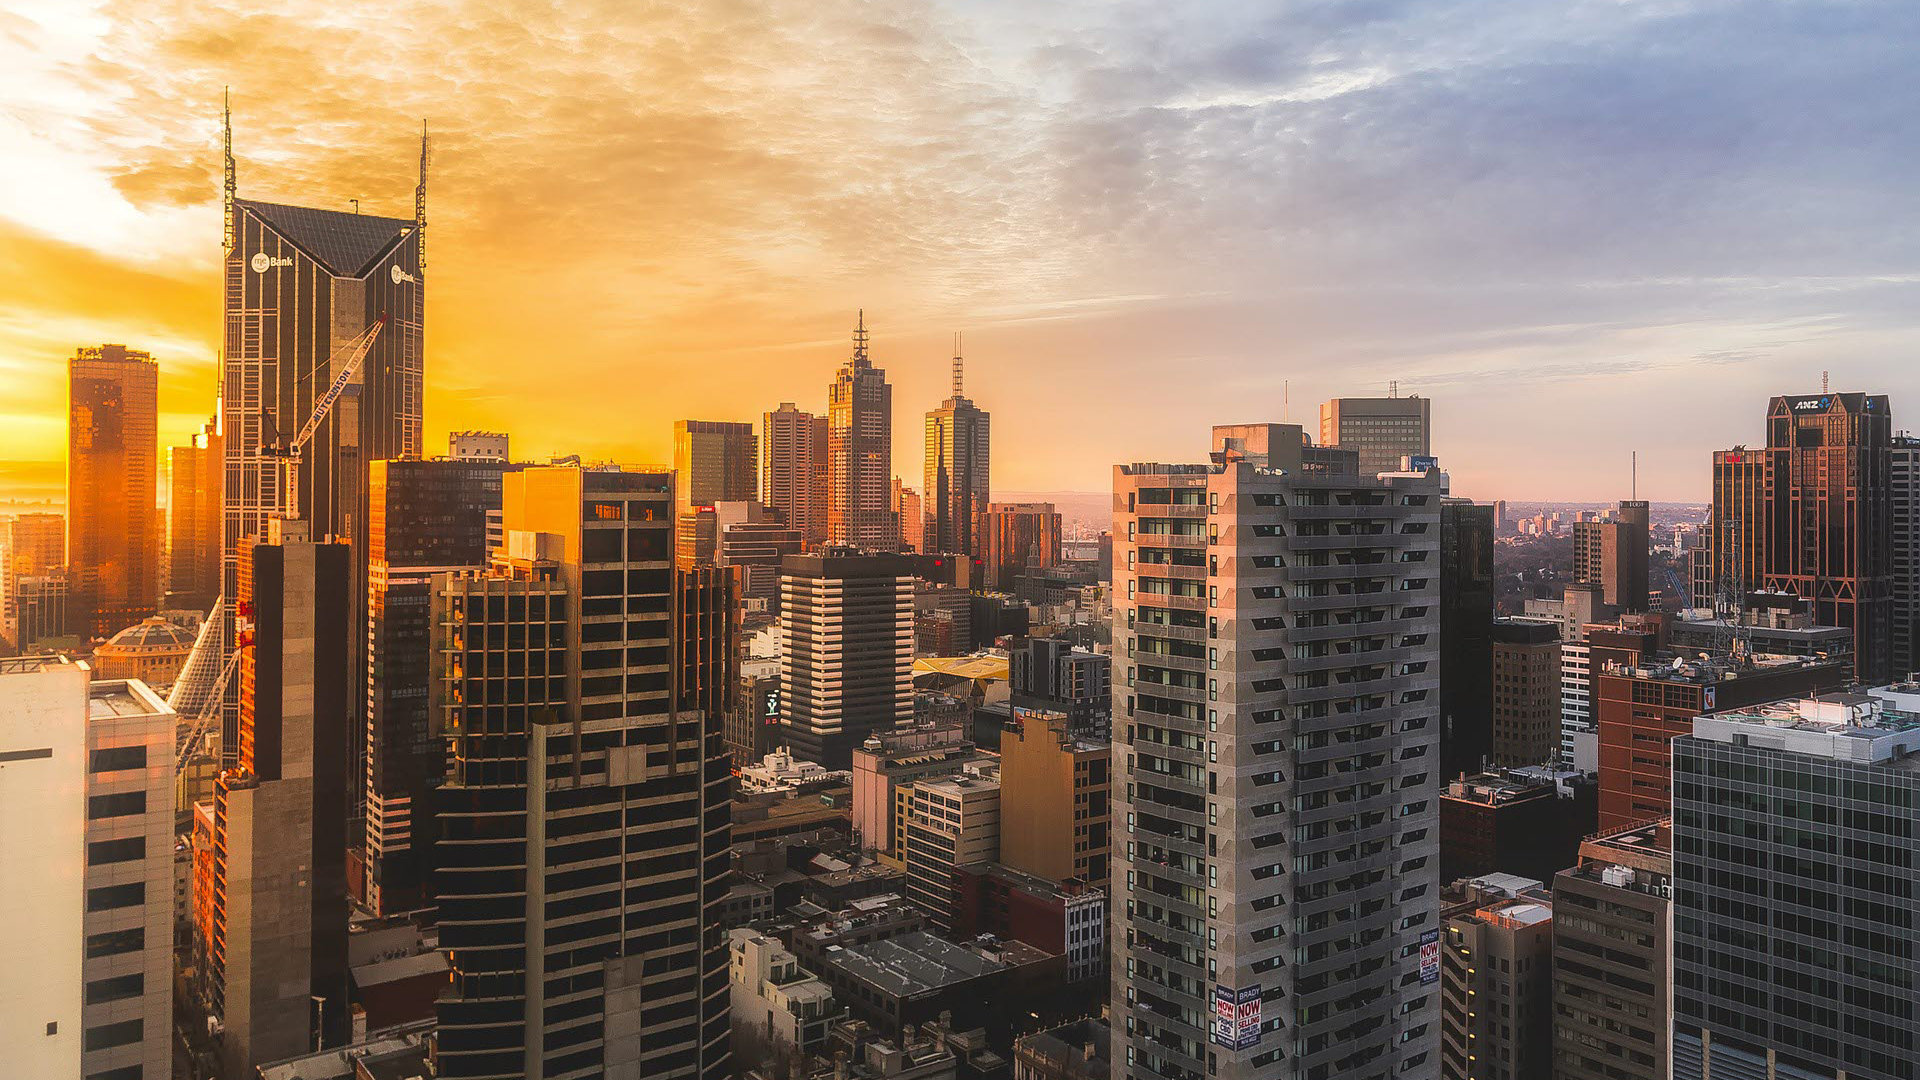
[353,457,513,915]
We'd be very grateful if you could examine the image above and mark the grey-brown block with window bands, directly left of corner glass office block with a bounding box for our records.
[1553,821,1672,1080]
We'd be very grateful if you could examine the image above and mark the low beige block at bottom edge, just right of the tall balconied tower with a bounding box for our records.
[1440,890,1553,1080]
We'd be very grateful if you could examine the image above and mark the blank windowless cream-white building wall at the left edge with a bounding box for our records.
[0,657,88,1078]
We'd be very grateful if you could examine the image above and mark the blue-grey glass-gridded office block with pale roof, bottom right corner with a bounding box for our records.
[1672,684,1920,1080]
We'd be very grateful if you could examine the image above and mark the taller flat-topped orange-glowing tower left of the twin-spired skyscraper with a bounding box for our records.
[67,346,159,638]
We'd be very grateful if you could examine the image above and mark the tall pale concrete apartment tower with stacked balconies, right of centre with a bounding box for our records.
[1112,425,1446,1080]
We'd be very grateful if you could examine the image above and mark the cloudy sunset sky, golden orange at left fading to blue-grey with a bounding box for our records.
[0,0,1920,502]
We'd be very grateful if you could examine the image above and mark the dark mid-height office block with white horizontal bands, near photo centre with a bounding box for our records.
[780,553,914,769]
